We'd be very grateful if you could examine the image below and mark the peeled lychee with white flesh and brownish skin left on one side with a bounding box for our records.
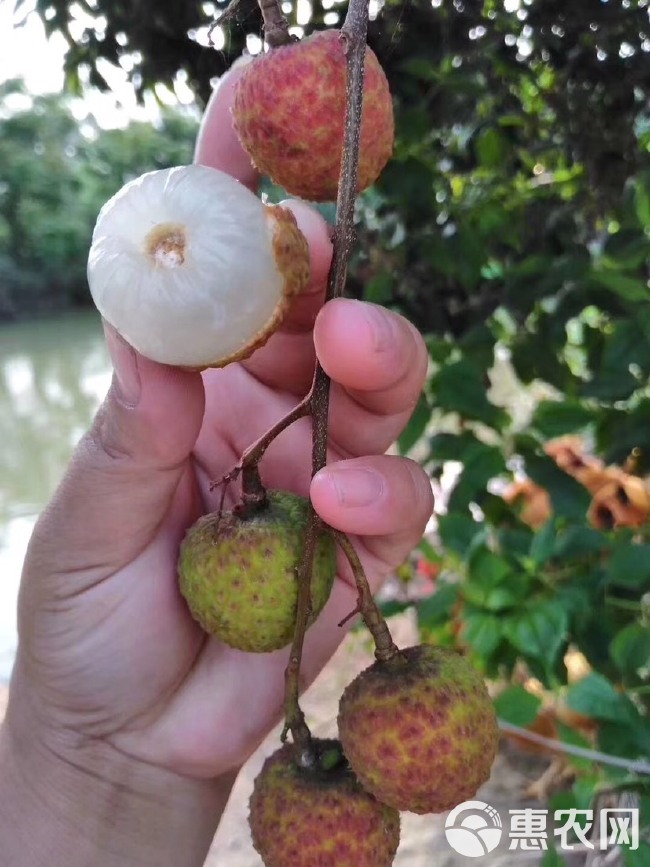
[88,165,309,369]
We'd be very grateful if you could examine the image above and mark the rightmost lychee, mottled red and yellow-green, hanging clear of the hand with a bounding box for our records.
[338,644,499,813]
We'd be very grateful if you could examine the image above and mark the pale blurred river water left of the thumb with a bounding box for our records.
[0,311,111,682]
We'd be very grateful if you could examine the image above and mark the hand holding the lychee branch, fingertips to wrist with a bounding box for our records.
[8,64,432,863]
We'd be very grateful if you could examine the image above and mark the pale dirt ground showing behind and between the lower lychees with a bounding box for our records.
[0,616,584,867]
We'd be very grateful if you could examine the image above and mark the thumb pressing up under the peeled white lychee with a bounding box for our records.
[28,325,204,580]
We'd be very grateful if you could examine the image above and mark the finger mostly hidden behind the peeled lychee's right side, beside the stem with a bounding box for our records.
[237,200,332,394]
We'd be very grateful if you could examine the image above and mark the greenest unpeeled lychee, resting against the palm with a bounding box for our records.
[178,491,336,653]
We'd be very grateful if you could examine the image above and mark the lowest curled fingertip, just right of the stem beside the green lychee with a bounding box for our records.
[310,455,433,571]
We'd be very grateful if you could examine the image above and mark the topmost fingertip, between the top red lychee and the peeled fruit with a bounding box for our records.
[194,64,260,191]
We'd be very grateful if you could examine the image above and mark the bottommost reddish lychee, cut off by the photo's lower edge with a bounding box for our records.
[249,741,400,867]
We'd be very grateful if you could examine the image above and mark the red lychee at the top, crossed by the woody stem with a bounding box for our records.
[232,30,394,202]
